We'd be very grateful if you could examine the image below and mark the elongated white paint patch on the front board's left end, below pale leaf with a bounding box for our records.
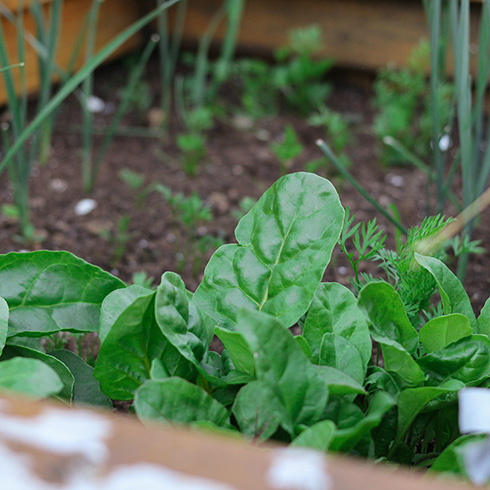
[0,408,111,463]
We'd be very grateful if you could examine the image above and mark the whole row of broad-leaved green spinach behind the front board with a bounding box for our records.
[0,173,490,482]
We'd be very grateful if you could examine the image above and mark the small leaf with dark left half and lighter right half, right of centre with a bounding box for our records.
[318,333,366,386]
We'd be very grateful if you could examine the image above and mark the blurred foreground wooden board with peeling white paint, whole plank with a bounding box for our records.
[0,393,474,490]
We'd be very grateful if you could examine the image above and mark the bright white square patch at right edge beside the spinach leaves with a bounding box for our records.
[458,388,490,434]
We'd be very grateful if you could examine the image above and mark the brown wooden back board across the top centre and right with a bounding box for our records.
[179,0,480,70]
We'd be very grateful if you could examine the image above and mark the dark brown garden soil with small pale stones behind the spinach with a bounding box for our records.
[0,54,490,309]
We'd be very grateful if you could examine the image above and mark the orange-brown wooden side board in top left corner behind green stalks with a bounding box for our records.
[0,0,143,104]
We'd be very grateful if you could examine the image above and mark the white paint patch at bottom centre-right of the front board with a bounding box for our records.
[267,448,332,490]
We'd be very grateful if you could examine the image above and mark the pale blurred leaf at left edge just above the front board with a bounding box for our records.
[0,357,63,398]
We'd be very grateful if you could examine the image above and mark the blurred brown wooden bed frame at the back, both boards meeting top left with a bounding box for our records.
[0,0,483,104]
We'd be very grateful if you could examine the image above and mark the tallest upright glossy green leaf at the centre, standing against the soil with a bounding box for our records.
[195,173,344,330]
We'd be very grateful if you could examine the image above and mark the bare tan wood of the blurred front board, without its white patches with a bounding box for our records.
[0,393,474,490]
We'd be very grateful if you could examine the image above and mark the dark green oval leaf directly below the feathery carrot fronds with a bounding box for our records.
[358,281,418,354]
